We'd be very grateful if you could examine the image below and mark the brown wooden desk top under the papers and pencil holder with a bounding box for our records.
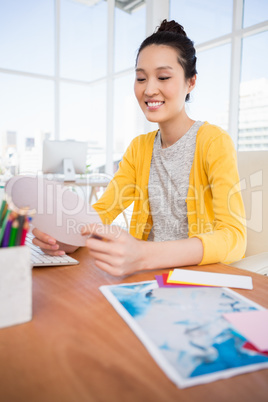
[0,249,268,402]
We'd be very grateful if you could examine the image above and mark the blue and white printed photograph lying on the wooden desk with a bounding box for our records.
[100,281,268,388]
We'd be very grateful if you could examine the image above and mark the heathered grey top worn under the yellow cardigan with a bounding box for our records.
[148,121,203,241]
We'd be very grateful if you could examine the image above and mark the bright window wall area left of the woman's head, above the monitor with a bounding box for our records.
[0,0,146,173]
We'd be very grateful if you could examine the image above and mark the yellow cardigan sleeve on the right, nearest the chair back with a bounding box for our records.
[194,134,246,265]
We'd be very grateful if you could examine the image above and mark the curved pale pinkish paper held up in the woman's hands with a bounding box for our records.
[6,176,101,246]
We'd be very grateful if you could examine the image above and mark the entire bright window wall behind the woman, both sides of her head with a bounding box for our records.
[0,0,268,179]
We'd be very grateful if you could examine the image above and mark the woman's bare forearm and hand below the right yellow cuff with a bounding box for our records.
[81,224,204,276]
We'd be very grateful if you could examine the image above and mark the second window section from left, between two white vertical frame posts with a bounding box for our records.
[59,0,108,170]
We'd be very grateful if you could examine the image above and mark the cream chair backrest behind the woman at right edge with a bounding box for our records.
[237,151,268,256]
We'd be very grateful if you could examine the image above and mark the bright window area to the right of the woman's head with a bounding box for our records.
[170,0,268,150]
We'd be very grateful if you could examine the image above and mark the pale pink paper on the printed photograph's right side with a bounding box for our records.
[223,310,268,352]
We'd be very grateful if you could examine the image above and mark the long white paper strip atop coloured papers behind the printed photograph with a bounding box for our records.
[168,269,253,289]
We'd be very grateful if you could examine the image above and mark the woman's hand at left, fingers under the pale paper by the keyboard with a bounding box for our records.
[32,228,78,256]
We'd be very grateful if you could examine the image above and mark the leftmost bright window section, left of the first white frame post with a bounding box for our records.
[0,0,55,173]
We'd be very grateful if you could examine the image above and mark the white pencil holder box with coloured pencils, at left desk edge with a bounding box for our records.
[0,246,32,328]
